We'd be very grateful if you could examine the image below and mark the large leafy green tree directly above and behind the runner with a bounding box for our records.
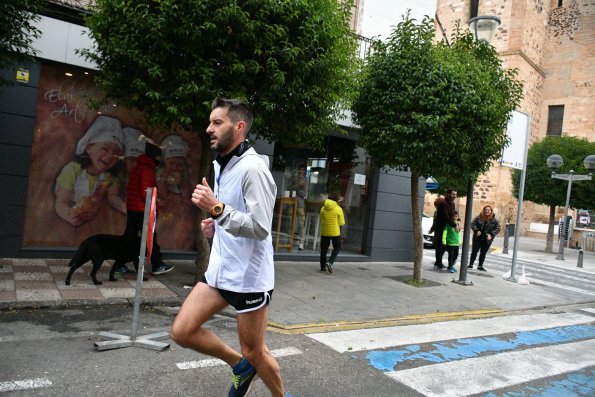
[84,0,358,276]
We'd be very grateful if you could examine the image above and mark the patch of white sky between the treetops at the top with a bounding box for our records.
[361,0,436,39]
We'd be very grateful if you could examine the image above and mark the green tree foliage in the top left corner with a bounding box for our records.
[0,0,46,85]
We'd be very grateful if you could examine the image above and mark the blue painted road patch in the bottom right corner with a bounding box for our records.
[485,370,595,397]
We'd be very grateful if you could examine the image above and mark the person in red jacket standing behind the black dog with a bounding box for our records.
[114,141,174,275]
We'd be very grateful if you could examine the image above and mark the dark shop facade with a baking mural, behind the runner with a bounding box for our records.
[0,1,423,261]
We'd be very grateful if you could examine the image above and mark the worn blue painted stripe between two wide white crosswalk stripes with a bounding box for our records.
[366,325,595,371]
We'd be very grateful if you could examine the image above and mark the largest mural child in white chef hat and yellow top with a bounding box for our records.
[54,115,126,226]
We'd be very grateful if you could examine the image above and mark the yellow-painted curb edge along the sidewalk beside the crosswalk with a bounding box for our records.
[267,309,507,334]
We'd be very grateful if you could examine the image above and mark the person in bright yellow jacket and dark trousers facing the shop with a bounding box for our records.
[320,191,345,273]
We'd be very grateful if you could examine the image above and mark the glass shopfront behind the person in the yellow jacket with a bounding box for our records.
[273,136,369,256]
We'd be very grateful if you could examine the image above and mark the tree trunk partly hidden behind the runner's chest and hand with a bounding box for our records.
[194,132,213,284]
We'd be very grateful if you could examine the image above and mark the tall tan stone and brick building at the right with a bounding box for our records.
[424,0,595,233]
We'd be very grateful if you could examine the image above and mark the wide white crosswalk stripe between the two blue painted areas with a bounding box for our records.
[386,340,595,397]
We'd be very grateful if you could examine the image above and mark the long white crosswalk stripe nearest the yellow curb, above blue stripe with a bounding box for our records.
[307,313,593,353]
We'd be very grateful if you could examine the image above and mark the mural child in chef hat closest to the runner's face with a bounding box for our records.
[157,135,193,209]
